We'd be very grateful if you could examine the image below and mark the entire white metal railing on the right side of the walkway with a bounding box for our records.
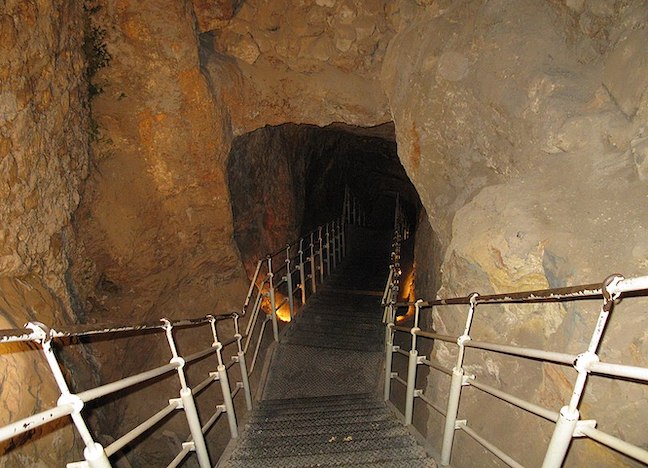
[383,225,648,468]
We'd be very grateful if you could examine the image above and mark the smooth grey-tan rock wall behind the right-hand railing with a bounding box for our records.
[382,1,648,466]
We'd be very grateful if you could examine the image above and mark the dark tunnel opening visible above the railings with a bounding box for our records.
[227,122,421,271]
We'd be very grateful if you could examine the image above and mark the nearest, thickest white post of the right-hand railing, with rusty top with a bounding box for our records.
[542,275,623,468]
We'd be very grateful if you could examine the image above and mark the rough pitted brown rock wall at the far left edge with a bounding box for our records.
[0,0,92,466]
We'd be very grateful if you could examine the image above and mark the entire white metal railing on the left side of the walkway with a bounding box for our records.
[0,185,366,468]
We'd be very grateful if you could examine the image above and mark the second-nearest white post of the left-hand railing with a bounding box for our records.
[161,318,210,468]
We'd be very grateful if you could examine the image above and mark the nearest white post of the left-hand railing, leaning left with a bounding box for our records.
[26,322,111,468]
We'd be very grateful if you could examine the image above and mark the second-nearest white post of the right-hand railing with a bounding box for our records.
[441,293,479,466]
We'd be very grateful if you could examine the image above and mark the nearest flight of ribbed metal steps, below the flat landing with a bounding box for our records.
[222,394,436,468]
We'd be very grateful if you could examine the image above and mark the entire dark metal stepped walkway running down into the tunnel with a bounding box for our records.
[219,229,436,468]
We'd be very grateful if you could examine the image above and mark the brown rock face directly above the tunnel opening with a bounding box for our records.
[203,0,394,135]
